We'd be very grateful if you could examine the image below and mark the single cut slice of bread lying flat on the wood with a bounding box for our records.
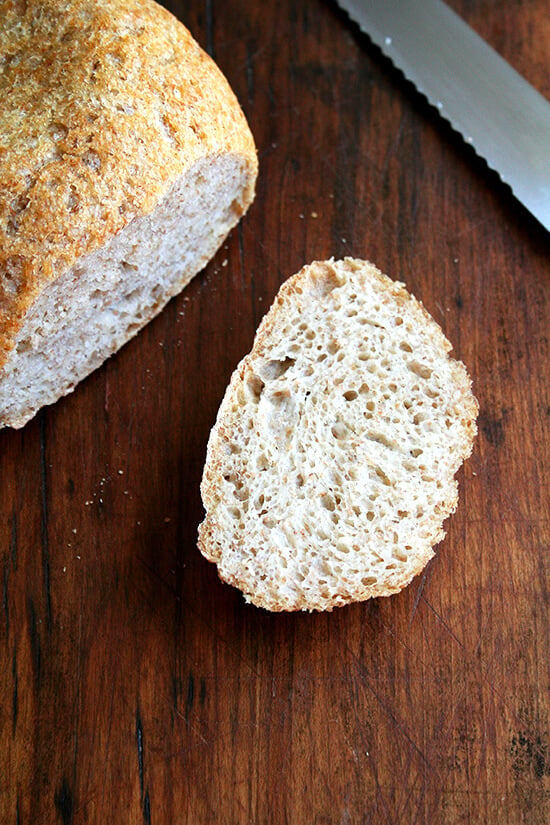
[199,258,478,611]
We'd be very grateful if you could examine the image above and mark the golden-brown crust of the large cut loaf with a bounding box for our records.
[0,0,257,364]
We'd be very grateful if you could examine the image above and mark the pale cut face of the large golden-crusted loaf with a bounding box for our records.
[0,153,256,427]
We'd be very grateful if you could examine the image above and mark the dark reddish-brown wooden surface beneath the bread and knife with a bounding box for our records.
[0,0,550,825]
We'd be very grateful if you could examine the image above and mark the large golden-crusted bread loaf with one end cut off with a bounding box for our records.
[0,0,257,427]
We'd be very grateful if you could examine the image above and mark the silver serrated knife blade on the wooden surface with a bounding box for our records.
[338,0,550,230]
